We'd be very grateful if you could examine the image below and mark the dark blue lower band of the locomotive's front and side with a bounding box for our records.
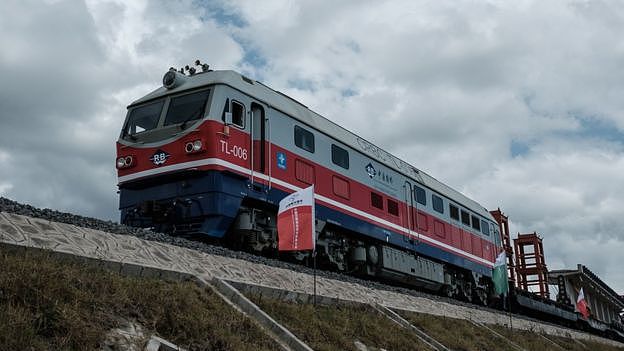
[119,171,492,277]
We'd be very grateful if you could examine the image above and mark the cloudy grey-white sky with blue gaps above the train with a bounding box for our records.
[0,0,624,294]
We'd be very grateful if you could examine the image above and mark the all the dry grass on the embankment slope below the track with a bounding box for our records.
[0,248,624,351]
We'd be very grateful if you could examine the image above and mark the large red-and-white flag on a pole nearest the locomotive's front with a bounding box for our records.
[277,185,316,251]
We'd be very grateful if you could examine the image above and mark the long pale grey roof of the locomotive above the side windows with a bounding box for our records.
[129,70,493,220]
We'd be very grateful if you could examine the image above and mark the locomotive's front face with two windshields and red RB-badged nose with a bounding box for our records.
[115,61,216,184]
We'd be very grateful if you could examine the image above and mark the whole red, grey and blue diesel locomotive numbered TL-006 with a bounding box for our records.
[116,61,502,304]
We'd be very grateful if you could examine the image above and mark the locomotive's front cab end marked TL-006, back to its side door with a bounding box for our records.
[116,67,270,238]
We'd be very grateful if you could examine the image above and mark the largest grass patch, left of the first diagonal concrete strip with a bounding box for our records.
[0,249,278,350]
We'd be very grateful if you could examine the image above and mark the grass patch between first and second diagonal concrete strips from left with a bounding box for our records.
[250,296,428,350]
